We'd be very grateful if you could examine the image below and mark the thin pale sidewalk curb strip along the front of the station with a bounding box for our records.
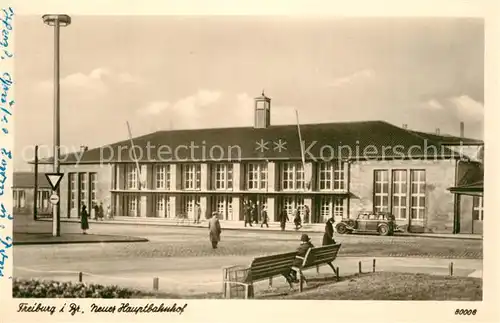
[38,219,483,241]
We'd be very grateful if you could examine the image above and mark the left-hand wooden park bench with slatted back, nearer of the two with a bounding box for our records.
[223,252,297,298]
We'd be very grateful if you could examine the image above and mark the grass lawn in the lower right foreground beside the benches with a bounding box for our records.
[268,272,483,301]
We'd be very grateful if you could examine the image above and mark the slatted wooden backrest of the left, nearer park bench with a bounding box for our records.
[247,252,297,281]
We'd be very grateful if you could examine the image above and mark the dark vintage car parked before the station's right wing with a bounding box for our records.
[335,212,399,236]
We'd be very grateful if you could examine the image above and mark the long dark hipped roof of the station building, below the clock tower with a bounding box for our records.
[36,121,464,164]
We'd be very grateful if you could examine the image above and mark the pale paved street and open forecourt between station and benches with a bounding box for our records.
[14,216,482,295]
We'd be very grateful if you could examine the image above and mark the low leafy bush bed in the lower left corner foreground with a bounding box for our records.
[12,278,139,298]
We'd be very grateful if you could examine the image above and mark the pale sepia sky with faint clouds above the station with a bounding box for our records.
[15,16,484,171]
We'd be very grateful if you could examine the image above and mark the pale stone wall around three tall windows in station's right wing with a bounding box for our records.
[349,160,456,233]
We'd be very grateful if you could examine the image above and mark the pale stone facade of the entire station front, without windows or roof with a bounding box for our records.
[35,160,462,233]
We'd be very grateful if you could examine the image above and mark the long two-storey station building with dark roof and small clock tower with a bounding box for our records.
[32,94,483,233]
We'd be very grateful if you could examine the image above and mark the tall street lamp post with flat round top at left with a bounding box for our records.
[42,14,71,237]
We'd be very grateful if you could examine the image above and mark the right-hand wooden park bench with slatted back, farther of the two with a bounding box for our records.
[292,244,341,292]
